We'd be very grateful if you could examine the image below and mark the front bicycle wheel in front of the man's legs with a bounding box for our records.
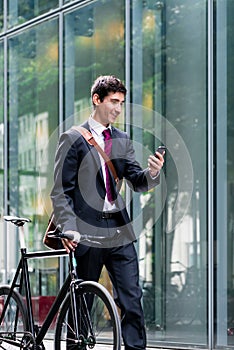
[55,281,121,350]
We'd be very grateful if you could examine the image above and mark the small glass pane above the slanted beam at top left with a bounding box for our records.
[7,0,59,28]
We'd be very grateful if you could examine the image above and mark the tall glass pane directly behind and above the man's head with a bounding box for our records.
[64,0,125,128]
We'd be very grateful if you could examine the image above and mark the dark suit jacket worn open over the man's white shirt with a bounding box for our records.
[51,122,159,249]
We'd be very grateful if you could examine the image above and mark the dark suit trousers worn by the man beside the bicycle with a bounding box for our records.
[76,243,146,350]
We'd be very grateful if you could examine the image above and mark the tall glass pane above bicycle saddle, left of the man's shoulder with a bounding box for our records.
[9,19,59,249]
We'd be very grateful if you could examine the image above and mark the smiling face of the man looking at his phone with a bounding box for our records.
[95,92,125,126]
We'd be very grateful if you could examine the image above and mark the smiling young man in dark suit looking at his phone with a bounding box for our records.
[51,76,164,350]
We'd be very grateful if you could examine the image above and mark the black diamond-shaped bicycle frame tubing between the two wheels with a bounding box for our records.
[0,248,73,345]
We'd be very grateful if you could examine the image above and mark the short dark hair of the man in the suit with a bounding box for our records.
[91,75,127,102]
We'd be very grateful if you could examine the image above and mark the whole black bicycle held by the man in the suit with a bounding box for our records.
[0,216,121,350]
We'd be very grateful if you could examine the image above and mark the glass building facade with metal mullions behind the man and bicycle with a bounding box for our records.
[0,0,234,349]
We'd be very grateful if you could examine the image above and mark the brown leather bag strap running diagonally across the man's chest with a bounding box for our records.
[72,126,119,183]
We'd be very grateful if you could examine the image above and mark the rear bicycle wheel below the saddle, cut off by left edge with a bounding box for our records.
[0,286,28,349]
